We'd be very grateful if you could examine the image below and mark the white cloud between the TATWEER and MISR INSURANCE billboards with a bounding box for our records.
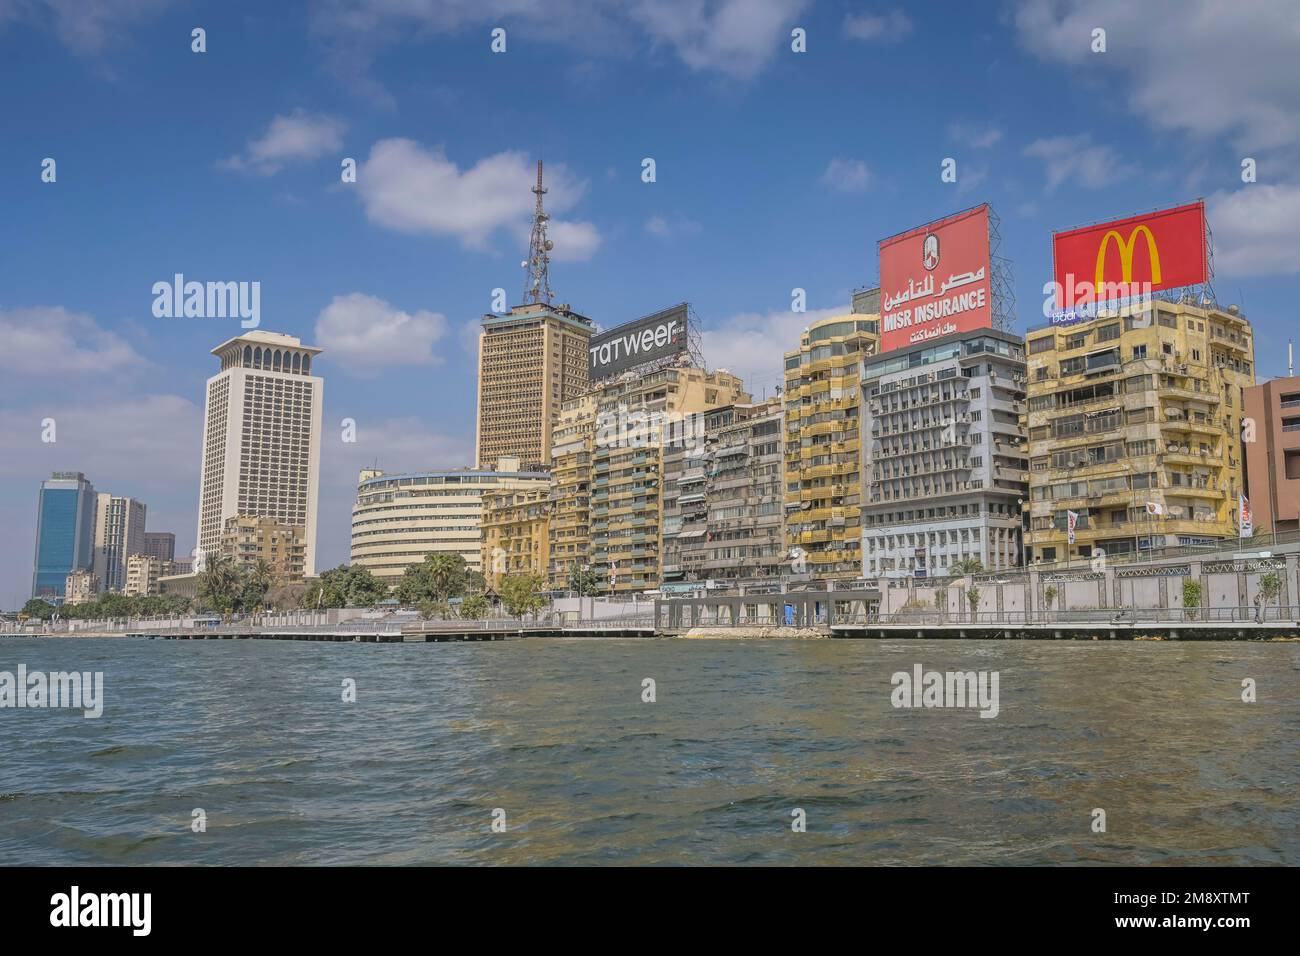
[699,306,849,398]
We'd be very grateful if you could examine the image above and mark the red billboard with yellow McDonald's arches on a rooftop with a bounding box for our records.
[1052,202,1206,307]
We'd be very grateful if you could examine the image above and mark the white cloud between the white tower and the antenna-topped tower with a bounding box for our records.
[316,293,447,375]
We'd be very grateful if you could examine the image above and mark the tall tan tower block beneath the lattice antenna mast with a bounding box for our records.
[475,302,594,468]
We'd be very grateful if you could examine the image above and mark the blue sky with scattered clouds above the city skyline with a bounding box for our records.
[0,0,1300,607]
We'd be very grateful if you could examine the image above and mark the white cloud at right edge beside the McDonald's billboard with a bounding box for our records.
[1206,185,1300,277]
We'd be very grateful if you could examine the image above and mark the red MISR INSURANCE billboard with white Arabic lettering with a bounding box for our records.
[880,203,993,352]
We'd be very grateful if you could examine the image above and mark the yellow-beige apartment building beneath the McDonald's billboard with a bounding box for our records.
[1026,300,1255,562]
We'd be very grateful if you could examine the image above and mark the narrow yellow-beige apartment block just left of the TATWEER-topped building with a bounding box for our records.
[547,393,595,589]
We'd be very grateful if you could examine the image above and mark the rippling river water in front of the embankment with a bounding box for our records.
[0,639,1300,865]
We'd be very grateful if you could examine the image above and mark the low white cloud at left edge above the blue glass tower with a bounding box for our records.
[0,306,150,378]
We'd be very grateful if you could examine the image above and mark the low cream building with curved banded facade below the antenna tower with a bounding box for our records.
[352,459,550,584]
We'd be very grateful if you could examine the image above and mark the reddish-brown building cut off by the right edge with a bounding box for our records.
[1243,377,1300,532]
